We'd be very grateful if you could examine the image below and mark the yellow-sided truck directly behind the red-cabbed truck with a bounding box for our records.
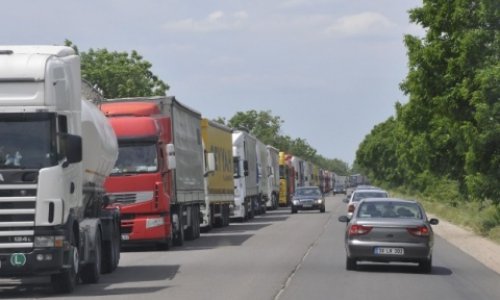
[201,118,234,230]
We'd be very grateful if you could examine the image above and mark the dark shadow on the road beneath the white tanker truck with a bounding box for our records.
[0,265,180,299]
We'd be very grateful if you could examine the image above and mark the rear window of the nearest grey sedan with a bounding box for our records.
[357,201,423,219]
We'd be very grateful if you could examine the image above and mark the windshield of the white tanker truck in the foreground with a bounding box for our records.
[0,113,57,169]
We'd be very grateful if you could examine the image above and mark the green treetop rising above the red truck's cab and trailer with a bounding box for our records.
[65,40,169,98]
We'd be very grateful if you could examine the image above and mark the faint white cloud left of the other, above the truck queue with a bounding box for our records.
[163,10,248,33]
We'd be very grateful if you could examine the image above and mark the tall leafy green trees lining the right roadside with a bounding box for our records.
[356,0,500,203]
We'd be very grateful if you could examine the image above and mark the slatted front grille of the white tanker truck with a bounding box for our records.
[0,184,36,252]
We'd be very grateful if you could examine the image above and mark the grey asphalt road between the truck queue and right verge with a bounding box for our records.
[0,195,500,300]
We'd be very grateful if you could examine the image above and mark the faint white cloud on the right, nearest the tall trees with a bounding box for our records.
[326,12,397,36]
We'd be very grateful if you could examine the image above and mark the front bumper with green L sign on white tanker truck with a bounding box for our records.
[0,248,69,277]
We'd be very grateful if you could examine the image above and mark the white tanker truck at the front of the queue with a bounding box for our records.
[0,45,120,293]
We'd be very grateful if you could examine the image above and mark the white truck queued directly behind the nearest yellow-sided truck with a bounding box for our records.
[231,129,260,220]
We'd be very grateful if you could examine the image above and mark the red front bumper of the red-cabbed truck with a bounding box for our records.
[121,215,171,244]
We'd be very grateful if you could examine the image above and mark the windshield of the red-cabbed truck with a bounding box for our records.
[111,143,158,175]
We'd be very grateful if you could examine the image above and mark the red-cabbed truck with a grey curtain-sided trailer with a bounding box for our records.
[101,96,205,250]
